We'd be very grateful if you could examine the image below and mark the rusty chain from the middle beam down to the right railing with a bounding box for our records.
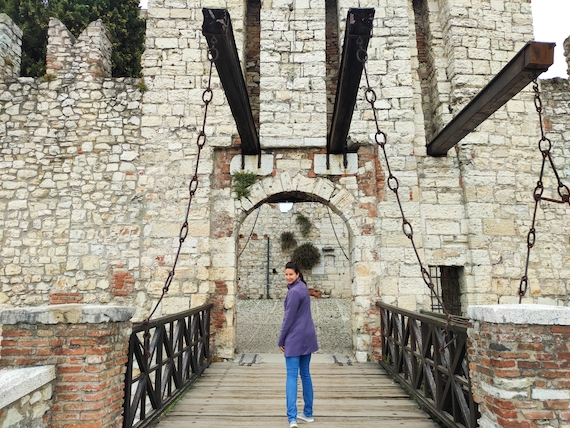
[356,37,455,353]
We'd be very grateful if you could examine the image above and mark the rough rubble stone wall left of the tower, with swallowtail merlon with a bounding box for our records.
[0,15,142,312]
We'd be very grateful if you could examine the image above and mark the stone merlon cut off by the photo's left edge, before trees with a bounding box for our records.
[0,13,22,80]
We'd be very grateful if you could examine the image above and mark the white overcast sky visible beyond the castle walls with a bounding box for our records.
[141,0,570,79]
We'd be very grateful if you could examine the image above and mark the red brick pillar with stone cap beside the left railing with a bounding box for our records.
[0,304,134,428]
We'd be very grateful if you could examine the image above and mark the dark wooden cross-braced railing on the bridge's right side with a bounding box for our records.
[377,302,479,428]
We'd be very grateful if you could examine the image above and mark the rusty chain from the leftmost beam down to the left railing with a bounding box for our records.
[142,36,218,357]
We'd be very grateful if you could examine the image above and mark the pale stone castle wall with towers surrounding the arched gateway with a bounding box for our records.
[0,0,570,359]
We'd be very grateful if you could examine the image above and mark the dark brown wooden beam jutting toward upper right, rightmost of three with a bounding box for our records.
[427,42,556,156]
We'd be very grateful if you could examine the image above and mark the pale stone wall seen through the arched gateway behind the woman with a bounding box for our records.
[237,202,352,299]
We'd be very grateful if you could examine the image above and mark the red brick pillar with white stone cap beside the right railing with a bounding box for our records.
[467,304,570,428]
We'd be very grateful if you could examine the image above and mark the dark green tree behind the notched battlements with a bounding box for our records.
[0,0,146,77]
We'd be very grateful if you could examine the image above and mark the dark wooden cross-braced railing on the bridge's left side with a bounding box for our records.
[123,304,213,428]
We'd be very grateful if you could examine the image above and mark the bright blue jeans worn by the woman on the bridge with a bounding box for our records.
[285,354,314,422]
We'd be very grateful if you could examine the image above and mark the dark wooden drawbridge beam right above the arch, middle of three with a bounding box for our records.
[327,9,374,154]
